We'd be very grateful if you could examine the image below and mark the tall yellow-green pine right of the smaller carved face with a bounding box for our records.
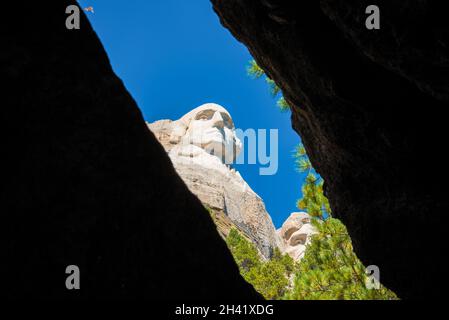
[285,145,397,300]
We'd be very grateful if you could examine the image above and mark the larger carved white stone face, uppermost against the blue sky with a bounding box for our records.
[173,103,241,163]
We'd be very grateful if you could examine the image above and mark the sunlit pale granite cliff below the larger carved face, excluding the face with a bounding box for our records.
[148,104,281,259]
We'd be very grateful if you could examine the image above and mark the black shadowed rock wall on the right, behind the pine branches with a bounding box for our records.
[212,0,449,298]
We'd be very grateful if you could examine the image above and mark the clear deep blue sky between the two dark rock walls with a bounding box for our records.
[79,0,304,227]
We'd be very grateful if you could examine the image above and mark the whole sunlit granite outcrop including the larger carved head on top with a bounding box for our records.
[148,103,281,258]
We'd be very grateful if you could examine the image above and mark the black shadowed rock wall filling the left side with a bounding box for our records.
[0,1,259,301]
